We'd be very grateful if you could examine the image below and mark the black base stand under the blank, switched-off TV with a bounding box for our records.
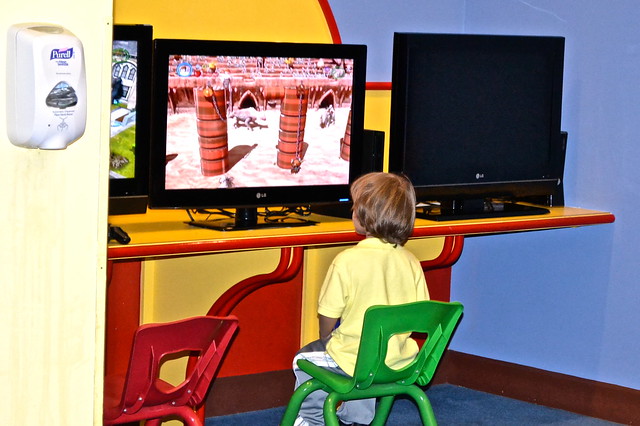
[416,200,549,221]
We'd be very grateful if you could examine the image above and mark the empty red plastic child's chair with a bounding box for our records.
[103,315,238,426]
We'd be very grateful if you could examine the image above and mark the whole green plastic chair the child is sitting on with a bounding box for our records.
[280,301,463,426]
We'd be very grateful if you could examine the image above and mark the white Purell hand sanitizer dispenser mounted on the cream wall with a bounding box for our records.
[7,23,87,149]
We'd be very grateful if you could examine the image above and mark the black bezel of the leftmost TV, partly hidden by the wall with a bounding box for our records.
[109,24,153,215]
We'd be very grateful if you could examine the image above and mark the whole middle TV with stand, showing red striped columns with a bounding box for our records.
[150,39,366,230]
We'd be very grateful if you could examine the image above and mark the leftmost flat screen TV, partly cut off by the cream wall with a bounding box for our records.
[109,25,153,214]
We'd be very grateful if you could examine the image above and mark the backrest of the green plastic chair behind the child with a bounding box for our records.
[353,300,463,389]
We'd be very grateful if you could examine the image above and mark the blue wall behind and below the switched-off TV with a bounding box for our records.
[330,0,640,389]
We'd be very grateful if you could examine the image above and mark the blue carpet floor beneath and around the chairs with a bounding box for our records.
[206,385,617,426]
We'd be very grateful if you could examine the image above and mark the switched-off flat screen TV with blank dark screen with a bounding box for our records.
[389,33,566,220]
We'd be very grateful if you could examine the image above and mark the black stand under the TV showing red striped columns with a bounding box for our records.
[185,207,317,231]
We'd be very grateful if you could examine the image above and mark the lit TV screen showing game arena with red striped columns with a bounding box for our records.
[165,52,353,189]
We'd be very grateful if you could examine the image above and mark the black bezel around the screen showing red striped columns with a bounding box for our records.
[149,39,366,209]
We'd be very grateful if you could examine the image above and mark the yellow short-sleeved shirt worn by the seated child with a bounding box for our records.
[318,238,429,375]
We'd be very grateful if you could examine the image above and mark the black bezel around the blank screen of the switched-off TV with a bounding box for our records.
[389,33,566,216]
